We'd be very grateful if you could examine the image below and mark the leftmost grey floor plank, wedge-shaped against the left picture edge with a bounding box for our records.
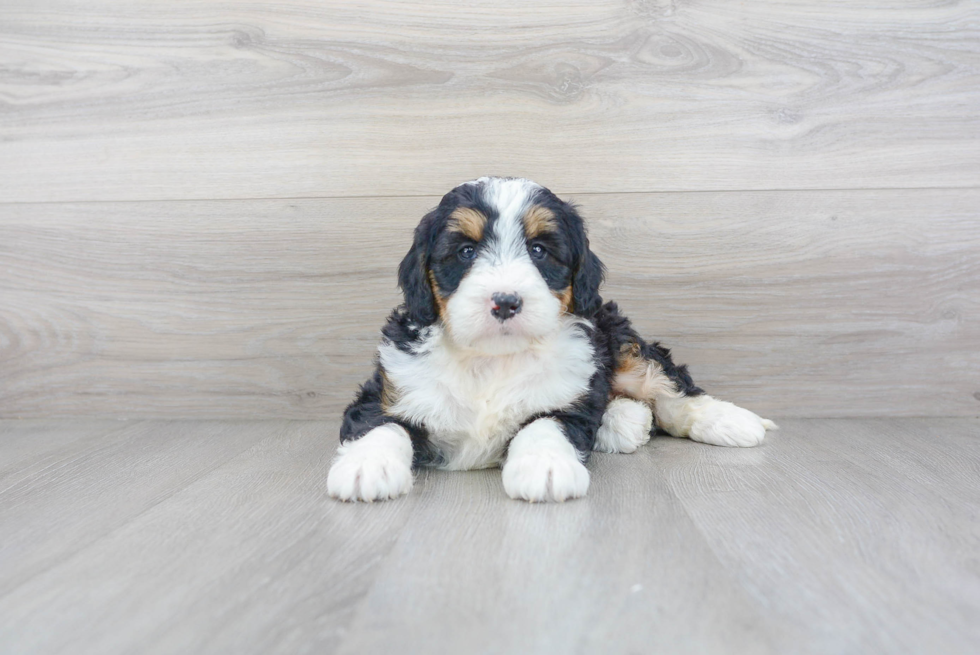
[0,422,272,595]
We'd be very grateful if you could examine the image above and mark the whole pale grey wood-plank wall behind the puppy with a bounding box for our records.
[0,0,980,418]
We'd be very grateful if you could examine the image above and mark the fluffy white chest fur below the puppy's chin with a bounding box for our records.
[379,319,596,470]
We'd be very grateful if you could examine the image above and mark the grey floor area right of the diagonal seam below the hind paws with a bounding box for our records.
[647,420,980,653]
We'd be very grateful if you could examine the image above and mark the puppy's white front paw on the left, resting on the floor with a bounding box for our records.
[327,423,412,502]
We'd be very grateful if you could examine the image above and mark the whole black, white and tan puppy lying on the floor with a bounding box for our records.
[327,177,776,501]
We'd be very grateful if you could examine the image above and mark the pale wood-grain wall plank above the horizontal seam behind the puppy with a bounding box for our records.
[0,0,980,202]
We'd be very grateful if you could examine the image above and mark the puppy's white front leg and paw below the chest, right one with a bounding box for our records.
[502,419,589,503]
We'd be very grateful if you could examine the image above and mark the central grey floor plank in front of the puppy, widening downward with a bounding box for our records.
[338,462,779,655]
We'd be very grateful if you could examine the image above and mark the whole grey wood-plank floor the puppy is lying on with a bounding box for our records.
[0,418,980,654]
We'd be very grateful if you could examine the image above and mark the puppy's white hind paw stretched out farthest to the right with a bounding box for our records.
[653,394,777,448]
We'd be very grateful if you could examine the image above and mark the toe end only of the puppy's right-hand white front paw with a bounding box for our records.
[502,454,589,503]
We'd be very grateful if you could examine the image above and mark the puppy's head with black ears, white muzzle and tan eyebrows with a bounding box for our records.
[398,177,603,354]
